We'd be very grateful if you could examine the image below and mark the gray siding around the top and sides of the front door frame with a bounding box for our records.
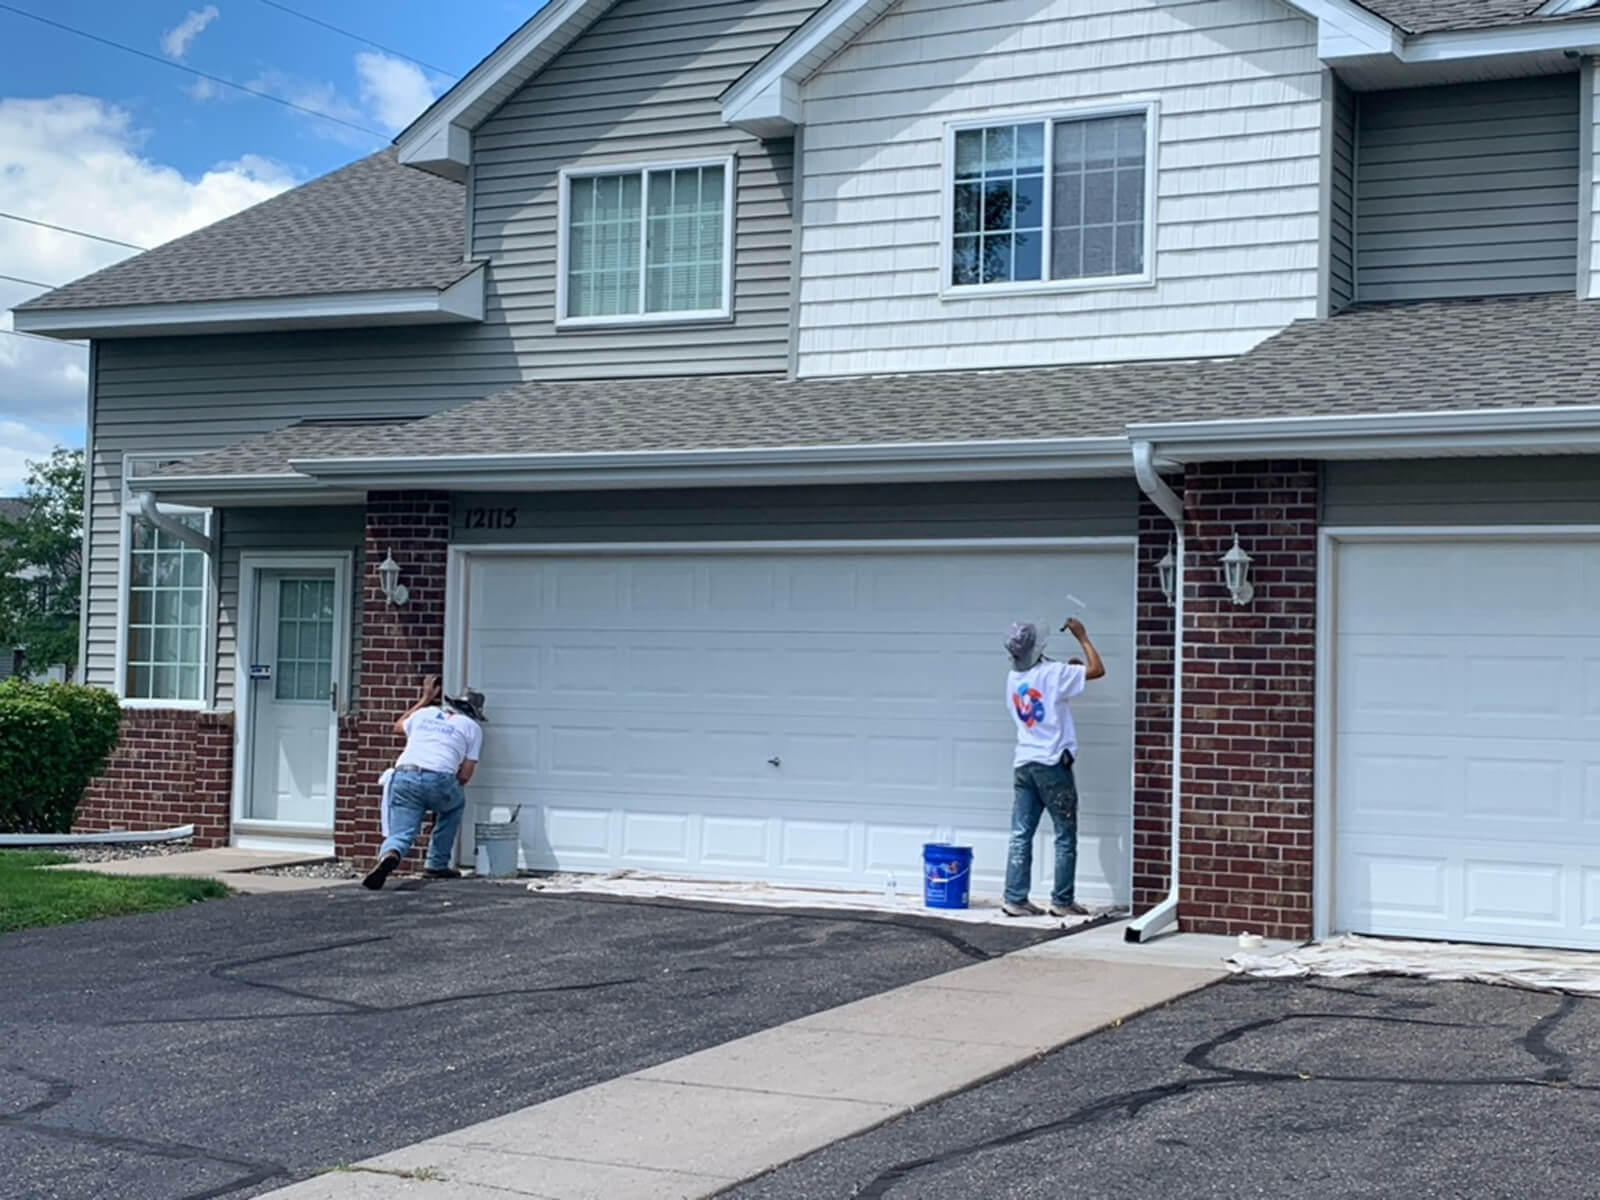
[216,506,366,709]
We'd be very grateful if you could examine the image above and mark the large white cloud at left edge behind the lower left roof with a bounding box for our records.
[0,96,296,460]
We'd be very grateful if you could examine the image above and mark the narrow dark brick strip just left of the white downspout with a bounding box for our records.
[1133,492,1182,914]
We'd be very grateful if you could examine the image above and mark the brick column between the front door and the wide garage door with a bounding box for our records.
[334,491,450,862]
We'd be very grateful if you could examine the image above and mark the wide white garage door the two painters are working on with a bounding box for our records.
[464,546,1133,902]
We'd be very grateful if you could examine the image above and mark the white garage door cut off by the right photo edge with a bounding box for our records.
[1334,541,1600,949]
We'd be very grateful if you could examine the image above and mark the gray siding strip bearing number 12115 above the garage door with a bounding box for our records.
[451,480,1139,546]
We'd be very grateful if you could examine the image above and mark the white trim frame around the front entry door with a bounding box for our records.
[229,550,355,848]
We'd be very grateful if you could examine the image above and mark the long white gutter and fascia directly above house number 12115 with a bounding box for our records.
[290,437,1133,491]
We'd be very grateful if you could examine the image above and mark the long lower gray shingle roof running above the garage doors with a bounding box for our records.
[150,294,1600,477]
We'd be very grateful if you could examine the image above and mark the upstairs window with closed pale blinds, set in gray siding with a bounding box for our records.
[560,158,734,325]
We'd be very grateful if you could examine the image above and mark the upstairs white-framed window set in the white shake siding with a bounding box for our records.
[947,109,1154,288]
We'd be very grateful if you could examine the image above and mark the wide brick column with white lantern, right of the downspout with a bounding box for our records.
[1179,462,1317,938]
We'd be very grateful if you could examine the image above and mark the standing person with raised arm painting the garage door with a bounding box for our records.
[1002,619,1106,917]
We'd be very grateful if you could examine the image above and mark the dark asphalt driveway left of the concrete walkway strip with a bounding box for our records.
[0,882,1050,1200]
